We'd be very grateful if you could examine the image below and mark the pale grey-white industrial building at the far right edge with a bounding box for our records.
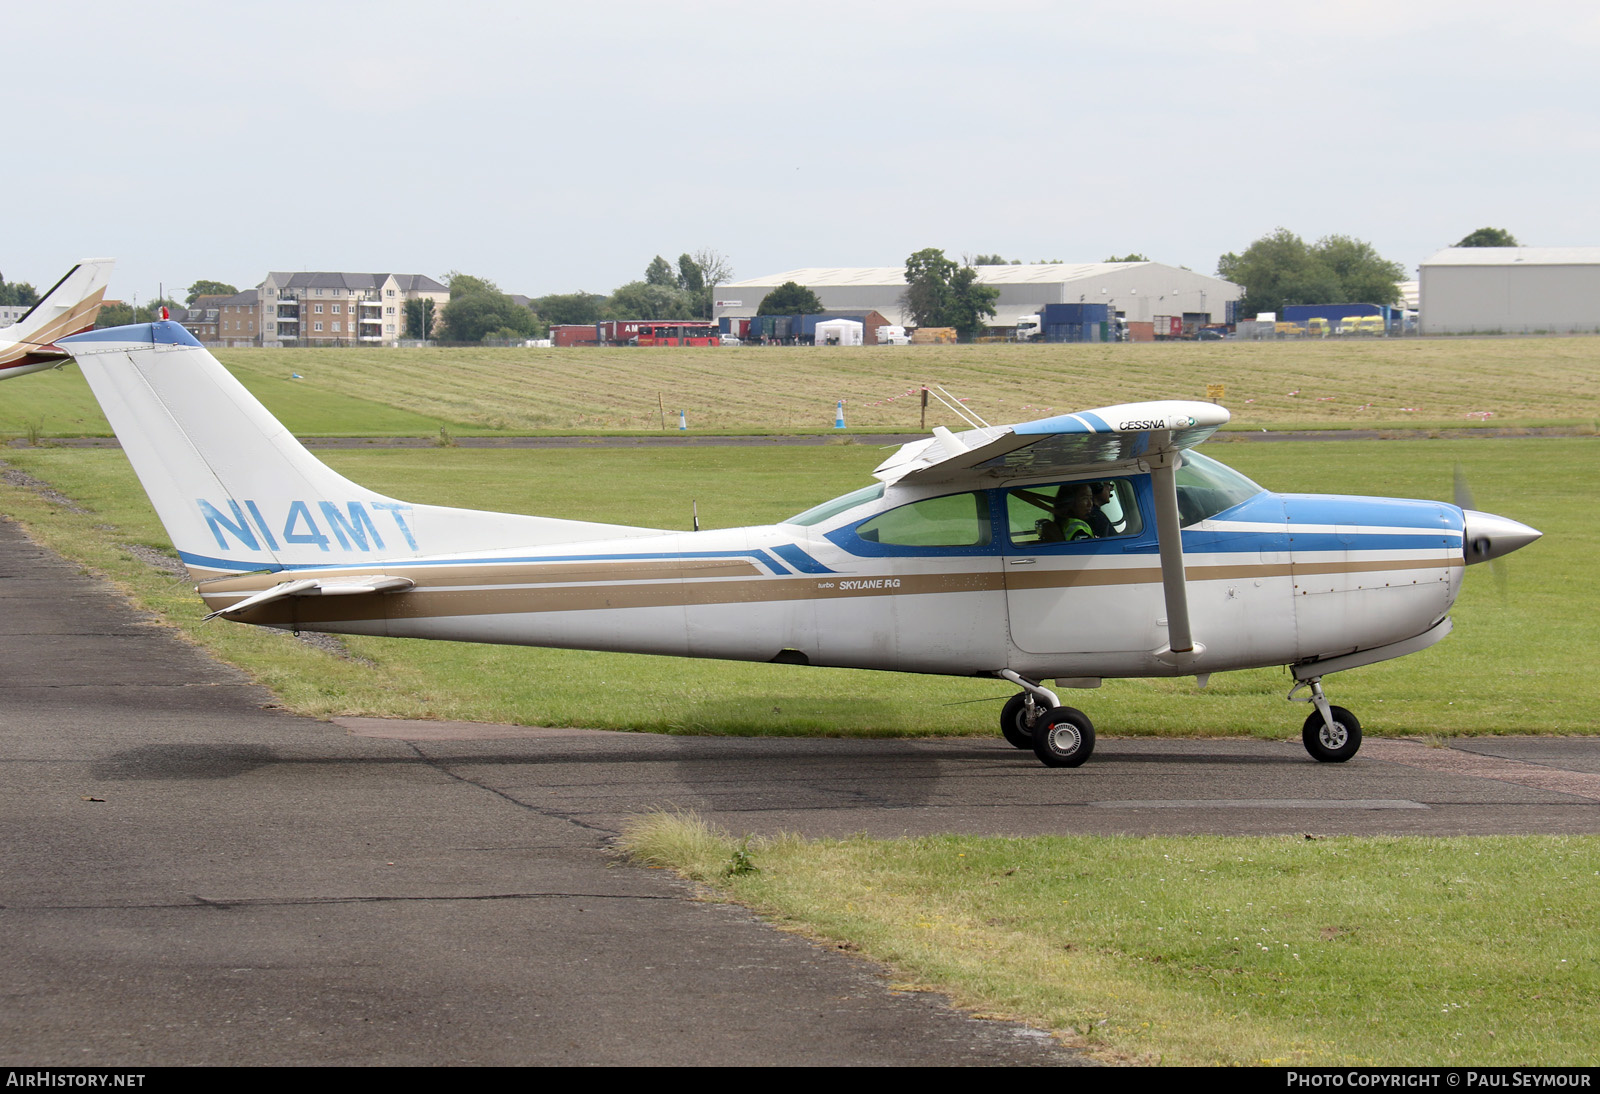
[1418,246,1600,334]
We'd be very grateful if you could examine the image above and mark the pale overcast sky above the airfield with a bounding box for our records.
[0,0,1600,301]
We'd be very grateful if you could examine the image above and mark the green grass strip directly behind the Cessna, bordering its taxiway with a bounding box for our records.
[3,438,1600,737]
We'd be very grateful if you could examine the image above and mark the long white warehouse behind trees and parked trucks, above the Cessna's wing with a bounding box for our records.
[712,262,1243,326]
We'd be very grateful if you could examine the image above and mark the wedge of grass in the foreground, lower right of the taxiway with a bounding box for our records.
[624,816,1600,1065]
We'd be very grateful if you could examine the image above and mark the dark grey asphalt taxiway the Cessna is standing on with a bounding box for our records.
[0,520,1600,1065]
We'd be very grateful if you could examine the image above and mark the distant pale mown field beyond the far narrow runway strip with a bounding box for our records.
[0,337,1600,437]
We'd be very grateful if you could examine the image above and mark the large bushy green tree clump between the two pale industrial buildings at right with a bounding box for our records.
[1216,227,1405,313]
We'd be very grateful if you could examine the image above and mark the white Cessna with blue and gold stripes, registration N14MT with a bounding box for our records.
[62,321,1539,766]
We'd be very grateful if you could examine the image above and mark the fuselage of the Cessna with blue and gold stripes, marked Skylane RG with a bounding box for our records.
[189,473,1464,678]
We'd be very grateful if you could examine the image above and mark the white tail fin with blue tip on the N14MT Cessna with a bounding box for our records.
[61,321,662,579]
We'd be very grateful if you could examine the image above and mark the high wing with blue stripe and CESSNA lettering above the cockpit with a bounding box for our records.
[872,400,1229,483]
